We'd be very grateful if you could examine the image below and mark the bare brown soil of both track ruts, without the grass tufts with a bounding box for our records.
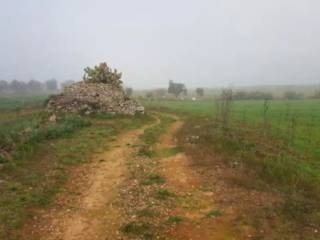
[20,114,275,240]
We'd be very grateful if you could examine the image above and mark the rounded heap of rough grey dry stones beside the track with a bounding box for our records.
[47,82,144,115]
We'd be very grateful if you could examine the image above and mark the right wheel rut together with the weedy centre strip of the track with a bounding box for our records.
[117,114,247,240]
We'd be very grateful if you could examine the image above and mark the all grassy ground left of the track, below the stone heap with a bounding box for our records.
[0,96,151,239]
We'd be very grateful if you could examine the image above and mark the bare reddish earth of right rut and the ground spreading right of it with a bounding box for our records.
[158,117,276,240]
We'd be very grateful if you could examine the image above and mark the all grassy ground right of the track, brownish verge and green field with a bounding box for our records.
[144,97,320,236]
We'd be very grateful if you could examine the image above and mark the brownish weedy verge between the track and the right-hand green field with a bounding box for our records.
[179,117,320,239]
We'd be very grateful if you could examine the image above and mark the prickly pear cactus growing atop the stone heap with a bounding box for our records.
[83,62,122,87]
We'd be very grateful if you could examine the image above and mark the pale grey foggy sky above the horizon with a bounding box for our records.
[0,0,320,88]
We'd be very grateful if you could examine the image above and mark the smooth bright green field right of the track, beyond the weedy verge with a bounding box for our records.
[144,100,320,159]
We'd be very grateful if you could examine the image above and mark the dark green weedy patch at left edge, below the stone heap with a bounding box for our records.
[0,112,90,164]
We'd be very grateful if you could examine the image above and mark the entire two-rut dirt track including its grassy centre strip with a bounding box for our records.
[24,114,248,240]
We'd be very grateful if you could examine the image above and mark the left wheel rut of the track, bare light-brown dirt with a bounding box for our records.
[25,122,155,240]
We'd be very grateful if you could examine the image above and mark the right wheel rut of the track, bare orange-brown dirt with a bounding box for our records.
[158,119,240,240]
